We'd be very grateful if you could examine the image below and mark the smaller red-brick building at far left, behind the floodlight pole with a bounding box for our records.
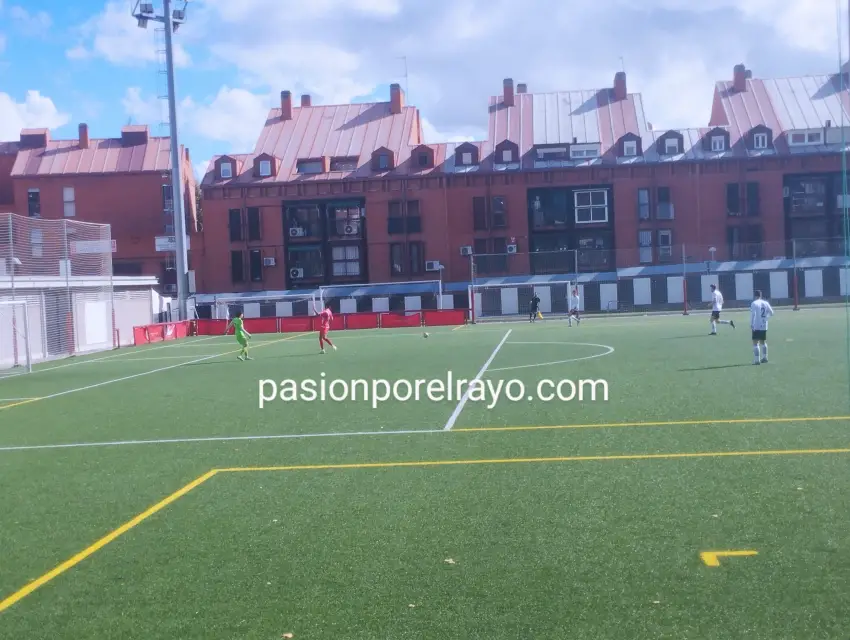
[0,124,197,291]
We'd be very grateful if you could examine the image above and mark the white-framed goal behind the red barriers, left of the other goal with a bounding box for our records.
[319,280,444,313]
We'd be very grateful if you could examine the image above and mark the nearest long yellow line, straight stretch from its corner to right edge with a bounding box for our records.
[219,449,850,473]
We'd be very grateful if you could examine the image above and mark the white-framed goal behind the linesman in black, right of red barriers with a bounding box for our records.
[469,280,584,322]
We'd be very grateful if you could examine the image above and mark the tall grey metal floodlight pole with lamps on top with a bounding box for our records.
[133,0,189,320]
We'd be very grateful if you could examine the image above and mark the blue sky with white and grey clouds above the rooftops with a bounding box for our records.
[0,0,848,180]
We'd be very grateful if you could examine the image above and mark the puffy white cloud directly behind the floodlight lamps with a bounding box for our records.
[65,2,190,67]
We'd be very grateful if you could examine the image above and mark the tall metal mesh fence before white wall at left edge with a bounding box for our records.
[0,213,115,369]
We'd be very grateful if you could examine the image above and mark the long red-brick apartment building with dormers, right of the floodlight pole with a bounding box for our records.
[193,65,850,293]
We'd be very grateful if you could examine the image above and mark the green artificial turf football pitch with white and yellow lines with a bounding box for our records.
[0,308,850,640]
